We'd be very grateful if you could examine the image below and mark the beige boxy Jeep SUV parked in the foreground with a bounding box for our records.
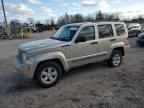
[15,22,129,87]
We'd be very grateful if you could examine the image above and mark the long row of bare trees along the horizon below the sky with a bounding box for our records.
[0,11,144,30]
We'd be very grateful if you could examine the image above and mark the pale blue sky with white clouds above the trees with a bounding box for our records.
[0,0,144,22]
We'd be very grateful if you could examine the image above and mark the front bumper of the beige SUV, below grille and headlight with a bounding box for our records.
[15,57,34,78]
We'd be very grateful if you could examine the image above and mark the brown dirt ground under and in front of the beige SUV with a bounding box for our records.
[0,37,144,108]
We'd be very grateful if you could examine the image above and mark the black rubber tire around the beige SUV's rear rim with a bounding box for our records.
[107,50,122,67]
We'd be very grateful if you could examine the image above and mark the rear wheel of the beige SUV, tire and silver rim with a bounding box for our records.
[107,50,122,67]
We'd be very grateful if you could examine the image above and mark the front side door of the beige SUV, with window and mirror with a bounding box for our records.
[68,25,97,68]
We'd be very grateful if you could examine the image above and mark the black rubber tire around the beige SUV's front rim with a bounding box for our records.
[35,61,62,88]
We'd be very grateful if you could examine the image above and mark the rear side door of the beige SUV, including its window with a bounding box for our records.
[97,24,116,60]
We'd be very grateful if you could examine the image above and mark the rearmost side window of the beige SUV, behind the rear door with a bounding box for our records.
[115,24,126,36]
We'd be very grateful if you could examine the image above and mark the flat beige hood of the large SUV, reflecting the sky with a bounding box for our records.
[19,39,67,52]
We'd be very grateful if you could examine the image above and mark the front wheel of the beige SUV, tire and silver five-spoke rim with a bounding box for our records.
[36,61,62,88]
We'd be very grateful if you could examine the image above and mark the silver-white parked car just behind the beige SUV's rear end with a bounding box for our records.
[128,23,141,37]
